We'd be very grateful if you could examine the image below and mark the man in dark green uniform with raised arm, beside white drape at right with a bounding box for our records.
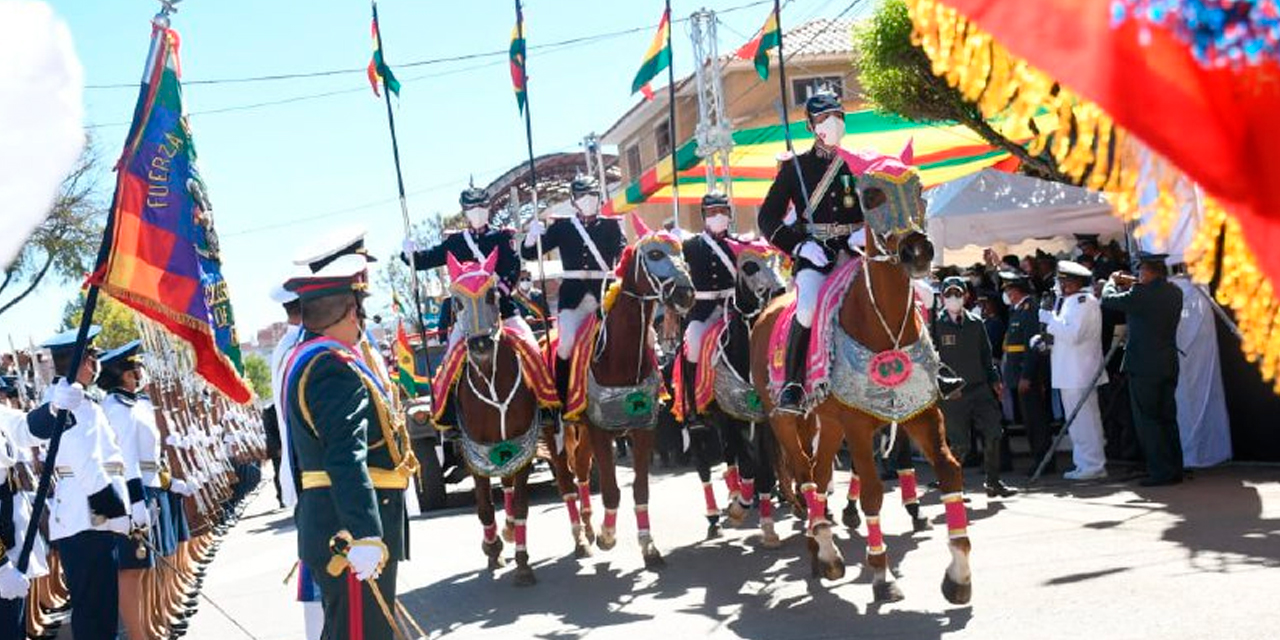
[1102,253,1183,486]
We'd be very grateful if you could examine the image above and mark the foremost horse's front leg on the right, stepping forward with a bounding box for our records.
[906,408,973,604]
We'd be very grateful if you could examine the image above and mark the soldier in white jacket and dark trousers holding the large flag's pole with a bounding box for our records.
[41,326,131,640]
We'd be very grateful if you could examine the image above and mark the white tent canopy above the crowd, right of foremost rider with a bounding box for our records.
[924,169,1124,264]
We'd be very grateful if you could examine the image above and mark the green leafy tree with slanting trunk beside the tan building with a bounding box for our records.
[854,0,1071,183]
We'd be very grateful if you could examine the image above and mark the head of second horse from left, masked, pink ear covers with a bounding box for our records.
[618,214,694,315]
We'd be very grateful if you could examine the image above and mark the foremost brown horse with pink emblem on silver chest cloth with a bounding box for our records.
[751,146,972,604]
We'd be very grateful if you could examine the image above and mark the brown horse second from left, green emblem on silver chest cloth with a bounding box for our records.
[564,215,694,570]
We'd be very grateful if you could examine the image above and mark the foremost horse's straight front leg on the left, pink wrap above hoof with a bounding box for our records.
[845,413,902,603]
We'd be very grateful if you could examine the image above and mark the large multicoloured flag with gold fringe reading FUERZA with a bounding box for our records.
[88,26,252,403]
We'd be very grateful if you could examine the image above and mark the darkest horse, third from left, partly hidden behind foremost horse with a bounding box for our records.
[687,241,785,549]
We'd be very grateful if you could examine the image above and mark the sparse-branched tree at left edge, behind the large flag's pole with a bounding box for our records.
[0,138,106,320]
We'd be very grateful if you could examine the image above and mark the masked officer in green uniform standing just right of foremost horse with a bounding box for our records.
[932,276,1018,498]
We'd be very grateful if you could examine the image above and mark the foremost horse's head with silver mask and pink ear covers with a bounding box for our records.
[841,142,933,278]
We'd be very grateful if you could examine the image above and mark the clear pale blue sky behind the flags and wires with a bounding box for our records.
[0,0,874,343]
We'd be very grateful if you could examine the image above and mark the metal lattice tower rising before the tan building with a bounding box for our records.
[672,9,733,217]
